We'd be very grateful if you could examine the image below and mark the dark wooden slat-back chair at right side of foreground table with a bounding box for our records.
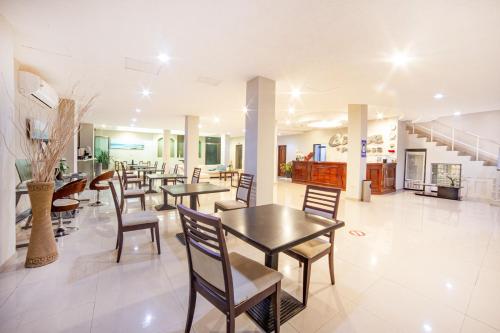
[284,185,341,306]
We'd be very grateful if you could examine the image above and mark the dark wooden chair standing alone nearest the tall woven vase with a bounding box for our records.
[108,181,161,262]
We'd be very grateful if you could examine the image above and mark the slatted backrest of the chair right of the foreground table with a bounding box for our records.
[302,185,341,219]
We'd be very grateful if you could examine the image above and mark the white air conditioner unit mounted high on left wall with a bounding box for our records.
[18,71,59,109]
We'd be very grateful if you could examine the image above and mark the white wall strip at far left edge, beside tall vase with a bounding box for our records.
[0,15,16,265]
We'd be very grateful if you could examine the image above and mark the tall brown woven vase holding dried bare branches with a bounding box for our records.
[0,95,95,267]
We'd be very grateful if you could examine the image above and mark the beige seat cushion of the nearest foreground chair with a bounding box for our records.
[229,252,283,304]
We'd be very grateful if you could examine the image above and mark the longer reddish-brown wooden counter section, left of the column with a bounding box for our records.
[292,161,347,191]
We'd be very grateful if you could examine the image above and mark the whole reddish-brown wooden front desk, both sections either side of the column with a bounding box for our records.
[292,161,396,194]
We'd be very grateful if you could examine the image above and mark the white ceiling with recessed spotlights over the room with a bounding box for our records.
[0,0,500,135]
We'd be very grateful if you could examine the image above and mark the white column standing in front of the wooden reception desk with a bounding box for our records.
[347,104,368,200]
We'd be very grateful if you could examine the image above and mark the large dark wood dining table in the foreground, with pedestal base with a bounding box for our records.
[216,204,345,332]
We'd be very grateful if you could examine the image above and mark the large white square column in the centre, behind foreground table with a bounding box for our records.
[245,76,276,205]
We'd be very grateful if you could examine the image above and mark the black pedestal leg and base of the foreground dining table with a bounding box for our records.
[247,253,305,332]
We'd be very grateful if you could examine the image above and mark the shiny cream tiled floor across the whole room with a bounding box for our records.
[0,181,500,333]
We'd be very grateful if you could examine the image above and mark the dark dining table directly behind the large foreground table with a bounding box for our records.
[159,183,229,245]
